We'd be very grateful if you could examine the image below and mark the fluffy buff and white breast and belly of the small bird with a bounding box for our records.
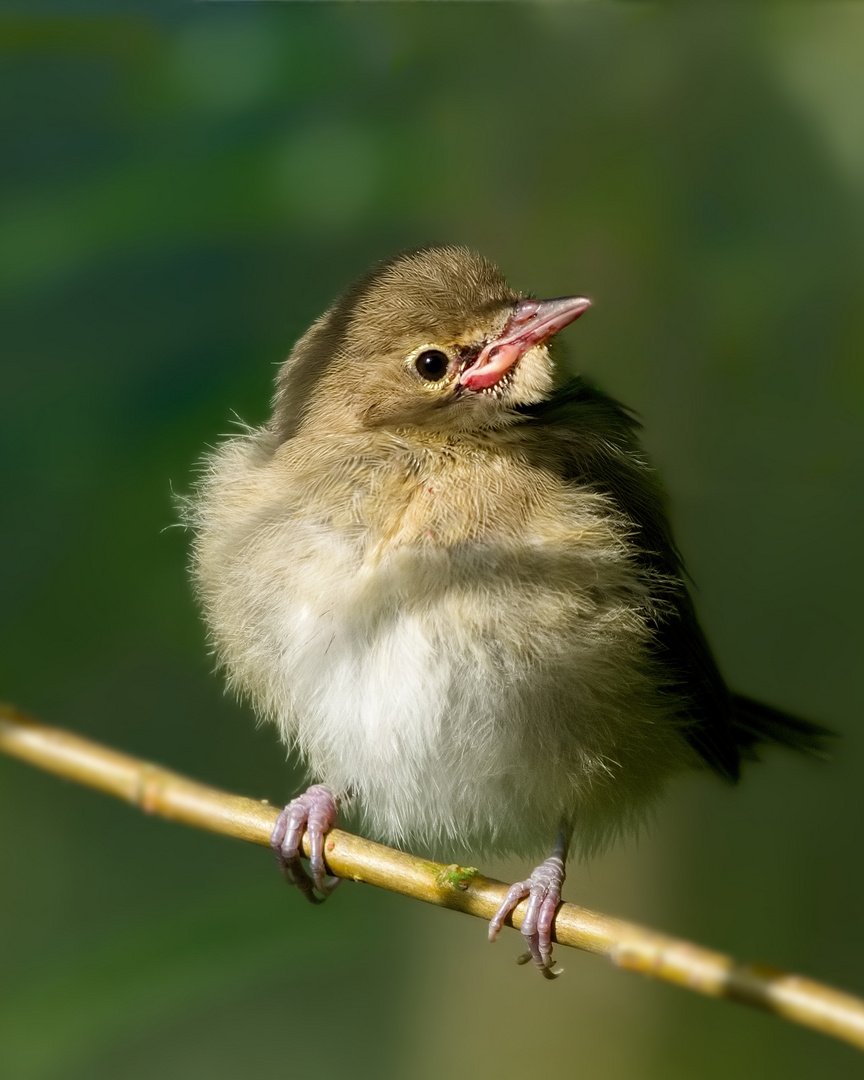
[197,435,693,858]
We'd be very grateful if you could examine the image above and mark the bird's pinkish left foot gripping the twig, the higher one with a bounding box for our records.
[270,784,339,904]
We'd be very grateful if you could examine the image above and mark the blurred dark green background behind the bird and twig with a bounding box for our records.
[0,3,864,1080]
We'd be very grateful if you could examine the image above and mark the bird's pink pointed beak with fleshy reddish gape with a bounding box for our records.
[459,296,591,390]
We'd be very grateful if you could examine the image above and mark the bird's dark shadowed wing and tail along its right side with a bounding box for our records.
[521,379,831,782]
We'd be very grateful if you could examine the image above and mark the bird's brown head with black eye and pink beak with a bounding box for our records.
[272,247,590,441]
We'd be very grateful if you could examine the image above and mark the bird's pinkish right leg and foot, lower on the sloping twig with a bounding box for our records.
[489,827,572,978]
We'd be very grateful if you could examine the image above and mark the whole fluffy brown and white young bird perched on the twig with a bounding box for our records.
[186,246,831,978]
